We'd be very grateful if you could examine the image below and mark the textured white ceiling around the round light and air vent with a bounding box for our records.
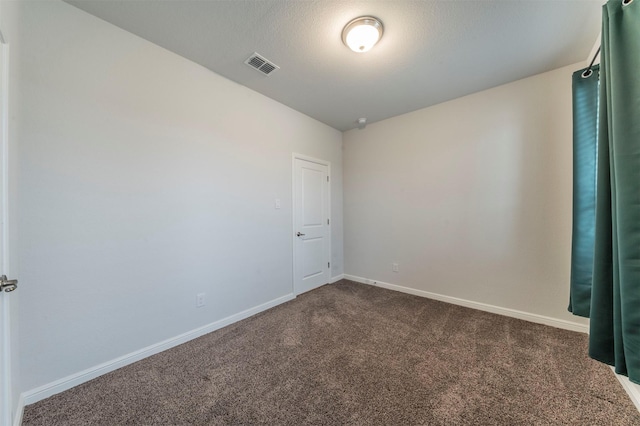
[67,0,604,130]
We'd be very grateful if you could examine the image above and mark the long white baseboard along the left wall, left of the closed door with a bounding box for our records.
[18,293,295,406]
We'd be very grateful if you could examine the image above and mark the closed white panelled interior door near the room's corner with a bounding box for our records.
[293,156,331,294]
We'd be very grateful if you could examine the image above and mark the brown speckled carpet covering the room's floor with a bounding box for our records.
[24,281,640,425]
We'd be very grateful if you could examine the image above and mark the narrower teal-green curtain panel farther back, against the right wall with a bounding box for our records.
[569,65,600,318]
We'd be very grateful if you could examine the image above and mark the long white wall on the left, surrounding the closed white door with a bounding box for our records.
[7,1,343,391]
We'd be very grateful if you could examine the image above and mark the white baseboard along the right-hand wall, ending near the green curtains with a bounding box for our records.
[344,274,589,333]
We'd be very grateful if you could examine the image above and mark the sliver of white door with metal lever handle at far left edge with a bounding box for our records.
[0,38,13,426]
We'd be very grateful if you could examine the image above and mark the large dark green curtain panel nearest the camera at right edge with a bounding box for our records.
[589,0,640,384]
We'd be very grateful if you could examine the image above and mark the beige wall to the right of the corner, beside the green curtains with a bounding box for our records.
[344,64,586,324]
